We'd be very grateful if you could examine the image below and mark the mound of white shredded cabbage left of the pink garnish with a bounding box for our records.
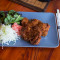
[0,24,18,45]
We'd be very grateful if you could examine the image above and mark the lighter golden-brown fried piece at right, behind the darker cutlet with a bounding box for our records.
[33,19,50,36]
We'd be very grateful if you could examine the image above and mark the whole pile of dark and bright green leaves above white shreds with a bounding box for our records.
[0,10,23,25]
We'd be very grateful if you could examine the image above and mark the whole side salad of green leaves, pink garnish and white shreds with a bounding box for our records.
[0,10,24,48]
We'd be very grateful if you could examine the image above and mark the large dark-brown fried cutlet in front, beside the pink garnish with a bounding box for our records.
[21,26,42,45]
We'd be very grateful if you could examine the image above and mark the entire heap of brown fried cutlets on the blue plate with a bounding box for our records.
[21,18,50,45]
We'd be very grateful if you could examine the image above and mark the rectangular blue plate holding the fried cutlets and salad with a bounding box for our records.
[0,12,59,48]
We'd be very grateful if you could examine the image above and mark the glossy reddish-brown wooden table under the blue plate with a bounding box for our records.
[0,0,60,60]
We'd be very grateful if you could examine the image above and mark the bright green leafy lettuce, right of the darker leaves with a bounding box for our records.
[4,10,23,24]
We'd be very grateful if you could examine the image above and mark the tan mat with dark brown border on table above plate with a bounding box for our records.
[10,0,49,12]
